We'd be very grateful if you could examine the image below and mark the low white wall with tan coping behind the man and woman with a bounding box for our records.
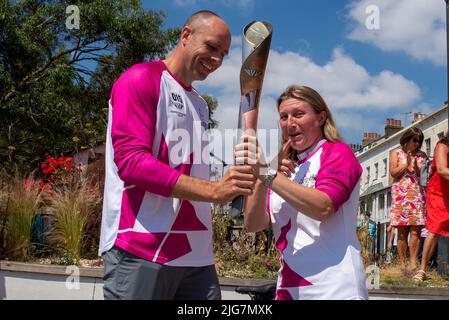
[0,261,449,300]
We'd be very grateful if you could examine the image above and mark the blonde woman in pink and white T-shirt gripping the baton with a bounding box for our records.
[235,86,368,300]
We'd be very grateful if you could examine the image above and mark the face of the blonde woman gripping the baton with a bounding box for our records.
[279,98,326,152]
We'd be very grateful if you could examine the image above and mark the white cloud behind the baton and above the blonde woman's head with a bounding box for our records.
[194,41,421,161]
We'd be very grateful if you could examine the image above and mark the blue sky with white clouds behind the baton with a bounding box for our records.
[142,0,447,154]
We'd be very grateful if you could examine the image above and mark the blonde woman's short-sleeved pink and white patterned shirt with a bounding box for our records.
[267,140,368,300]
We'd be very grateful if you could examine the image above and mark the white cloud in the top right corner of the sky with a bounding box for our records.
[348,0,446,65]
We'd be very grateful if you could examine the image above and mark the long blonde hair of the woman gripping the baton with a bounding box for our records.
[277,85,343,160]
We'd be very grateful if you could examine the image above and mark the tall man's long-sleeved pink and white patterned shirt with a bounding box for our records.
[99,61,214,266]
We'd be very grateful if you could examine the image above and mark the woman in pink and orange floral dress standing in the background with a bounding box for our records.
[390,127,427,275]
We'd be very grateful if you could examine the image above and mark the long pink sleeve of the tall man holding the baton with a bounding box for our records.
[111,64,181,196]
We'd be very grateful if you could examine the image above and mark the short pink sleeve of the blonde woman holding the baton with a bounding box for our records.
[315,142,362,211]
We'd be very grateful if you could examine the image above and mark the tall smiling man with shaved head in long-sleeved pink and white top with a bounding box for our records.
[99,11,255,299]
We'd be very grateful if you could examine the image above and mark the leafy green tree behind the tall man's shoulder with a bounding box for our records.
[0,0,179,172]
